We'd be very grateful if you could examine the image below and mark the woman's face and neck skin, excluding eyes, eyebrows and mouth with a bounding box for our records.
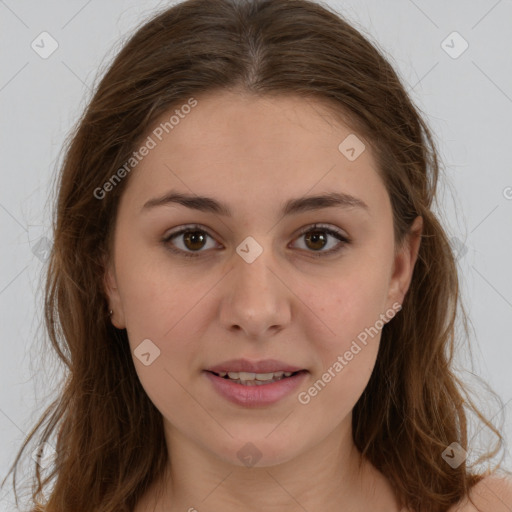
[105,91,456,512]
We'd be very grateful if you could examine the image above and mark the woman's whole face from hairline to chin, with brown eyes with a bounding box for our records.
[105,92,421,465]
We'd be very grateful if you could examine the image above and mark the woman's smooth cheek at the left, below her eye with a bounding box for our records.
[117,244,211,380]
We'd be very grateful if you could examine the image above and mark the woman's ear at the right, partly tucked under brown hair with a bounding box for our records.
[388,217,423,307]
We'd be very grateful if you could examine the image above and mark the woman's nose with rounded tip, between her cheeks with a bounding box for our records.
[220,244,293,339]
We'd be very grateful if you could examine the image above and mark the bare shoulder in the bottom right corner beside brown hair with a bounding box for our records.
[448,475,512,512]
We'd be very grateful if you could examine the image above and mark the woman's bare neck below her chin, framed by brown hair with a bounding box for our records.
[136,421,398,512]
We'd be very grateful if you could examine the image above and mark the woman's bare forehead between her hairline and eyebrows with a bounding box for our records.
[119,91,387,219]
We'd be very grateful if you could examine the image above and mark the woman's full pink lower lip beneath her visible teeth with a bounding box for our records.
[204,371,307,407]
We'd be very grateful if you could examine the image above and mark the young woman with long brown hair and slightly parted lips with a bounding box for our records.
[2,0,512,512]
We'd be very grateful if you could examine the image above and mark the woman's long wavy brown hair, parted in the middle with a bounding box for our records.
[4,0,502,512]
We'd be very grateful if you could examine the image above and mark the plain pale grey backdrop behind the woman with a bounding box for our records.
[0,0,512,510]
